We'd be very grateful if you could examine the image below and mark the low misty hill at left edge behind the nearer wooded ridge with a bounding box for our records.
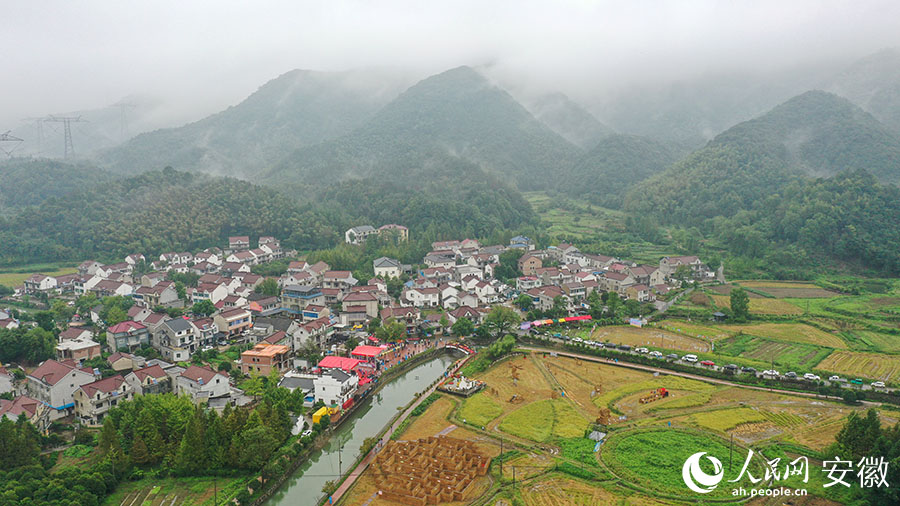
[0,158,118,215]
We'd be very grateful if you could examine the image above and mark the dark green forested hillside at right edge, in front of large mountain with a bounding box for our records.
[709,171,900,276]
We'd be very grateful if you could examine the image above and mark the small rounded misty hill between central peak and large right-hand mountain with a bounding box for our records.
[560,134,679,208]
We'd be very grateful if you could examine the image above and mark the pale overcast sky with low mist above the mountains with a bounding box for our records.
[0,0,900,132]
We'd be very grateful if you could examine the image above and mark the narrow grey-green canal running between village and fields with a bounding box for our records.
[266,353,456,506]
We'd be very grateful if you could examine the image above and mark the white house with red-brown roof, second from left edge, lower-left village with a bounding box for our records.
[26,359,96,420]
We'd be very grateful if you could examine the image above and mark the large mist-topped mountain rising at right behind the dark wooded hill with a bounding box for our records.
[626,91,900,224]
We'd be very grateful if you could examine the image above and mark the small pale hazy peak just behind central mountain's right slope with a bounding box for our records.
[524,93,615,149]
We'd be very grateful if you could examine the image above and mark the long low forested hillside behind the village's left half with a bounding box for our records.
[0,169,339,264]
